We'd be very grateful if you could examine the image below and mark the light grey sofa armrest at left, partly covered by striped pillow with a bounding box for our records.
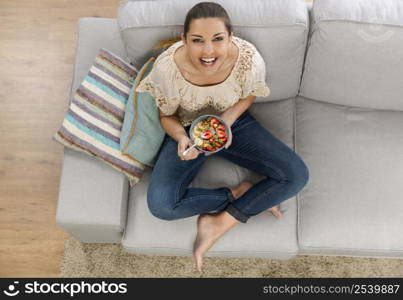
[56,18,129,243]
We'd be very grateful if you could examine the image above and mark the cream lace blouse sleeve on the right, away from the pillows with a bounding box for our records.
[242,50,270,98]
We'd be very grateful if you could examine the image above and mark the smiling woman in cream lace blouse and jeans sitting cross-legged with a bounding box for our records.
[137,2,308,271]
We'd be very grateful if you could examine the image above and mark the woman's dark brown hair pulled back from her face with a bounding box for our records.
[154,2,232,49]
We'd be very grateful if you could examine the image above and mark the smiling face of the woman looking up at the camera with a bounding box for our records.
[182,18,232,75]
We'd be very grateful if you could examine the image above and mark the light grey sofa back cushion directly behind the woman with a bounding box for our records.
[118,0,309,101]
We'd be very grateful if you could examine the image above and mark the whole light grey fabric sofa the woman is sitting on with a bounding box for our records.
[56,0,403,259]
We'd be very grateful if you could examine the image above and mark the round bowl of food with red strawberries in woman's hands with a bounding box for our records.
[189,115,232,153]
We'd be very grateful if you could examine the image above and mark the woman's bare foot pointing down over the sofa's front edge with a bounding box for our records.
[193,211,240,272]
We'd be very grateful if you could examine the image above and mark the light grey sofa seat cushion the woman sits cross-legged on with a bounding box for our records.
[122,99,298,258]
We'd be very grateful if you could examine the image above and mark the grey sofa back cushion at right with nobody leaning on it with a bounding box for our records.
[300,0,403,110]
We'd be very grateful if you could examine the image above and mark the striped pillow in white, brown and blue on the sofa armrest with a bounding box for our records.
[53,49,144,187]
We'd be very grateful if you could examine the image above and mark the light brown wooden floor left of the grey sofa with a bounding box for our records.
[0,0,120,277]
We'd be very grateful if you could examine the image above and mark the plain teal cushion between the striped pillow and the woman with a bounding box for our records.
[120,57,166,167]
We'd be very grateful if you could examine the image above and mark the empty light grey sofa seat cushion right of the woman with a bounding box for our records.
[295,97,403,257]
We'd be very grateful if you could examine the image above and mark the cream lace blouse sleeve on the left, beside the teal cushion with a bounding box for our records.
[136,62,179,116]
